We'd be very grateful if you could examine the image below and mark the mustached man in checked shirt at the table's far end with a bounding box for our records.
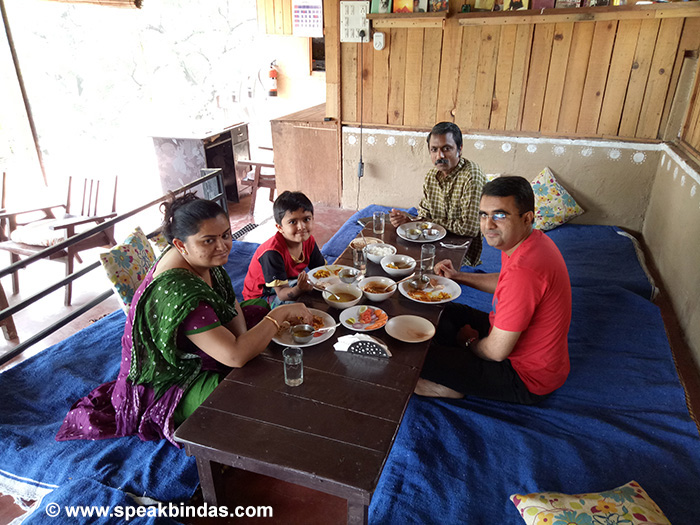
[390,122,486,266]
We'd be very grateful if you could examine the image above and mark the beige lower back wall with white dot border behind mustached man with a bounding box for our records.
[342,127,662,231]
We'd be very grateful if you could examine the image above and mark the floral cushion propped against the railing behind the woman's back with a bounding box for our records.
[100,227,155,312]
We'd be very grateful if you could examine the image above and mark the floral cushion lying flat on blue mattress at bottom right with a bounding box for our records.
[510,481,670,525]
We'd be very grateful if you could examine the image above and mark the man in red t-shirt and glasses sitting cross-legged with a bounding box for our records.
[416,177,571,404]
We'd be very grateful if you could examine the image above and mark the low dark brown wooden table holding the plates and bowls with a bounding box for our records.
[175,220,464,524]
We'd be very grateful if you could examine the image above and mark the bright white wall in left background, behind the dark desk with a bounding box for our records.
[0,0,325,209]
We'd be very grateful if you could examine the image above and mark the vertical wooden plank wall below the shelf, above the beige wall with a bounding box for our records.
[334,13,700,141]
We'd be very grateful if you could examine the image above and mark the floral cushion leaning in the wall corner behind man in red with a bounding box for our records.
[532,168,584,231]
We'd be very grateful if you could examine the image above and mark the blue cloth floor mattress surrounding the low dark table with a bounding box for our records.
[0,215,700,525]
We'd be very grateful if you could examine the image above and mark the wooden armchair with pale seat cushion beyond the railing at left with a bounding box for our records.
[0,177,117,306]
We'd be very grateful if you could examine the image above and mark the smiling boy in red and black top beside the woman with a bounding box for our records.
[243,191,326,307]
